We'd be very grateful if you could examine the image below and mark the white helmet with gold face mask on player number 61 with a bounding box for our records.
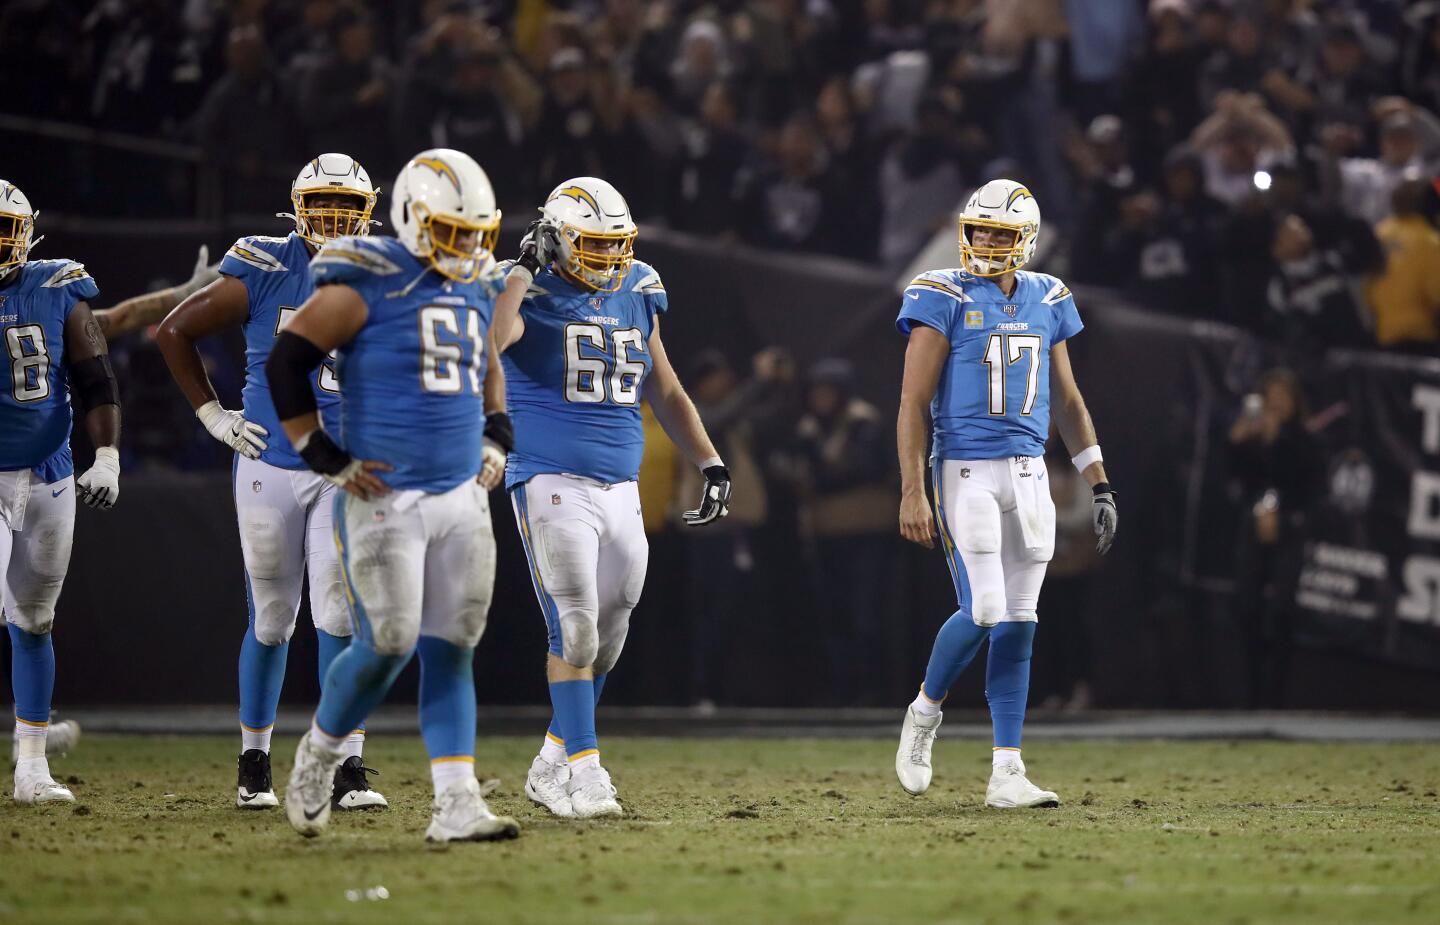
[390,148,500,282]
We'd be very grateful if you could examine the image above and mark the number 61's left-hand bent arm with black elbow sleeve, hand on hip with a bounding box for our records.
[265,284,393,500]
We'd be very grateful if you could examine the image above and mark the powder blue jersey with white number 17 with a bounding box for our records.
[896,269,1084,460]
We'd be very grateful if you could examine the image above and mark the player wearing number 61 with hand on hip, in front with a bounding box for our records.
[266,148,523,841]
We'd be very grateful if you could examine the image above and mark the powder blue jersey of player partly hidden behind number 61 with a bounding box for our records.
[220,232,340,470]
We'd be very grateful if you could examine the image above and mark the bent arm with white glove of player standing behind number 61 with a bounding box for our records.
[156,277,269,460]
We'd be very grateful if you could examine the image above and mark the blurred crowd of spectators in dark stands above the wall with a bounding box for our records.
[0,0,1440,350]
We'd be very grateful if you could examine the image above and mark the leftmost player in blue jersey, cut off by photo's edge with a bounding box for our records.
[0,180,120,804]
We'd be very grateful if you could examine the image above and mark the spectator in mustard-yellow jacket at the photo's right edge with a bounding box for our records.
[1367,180,1440,352]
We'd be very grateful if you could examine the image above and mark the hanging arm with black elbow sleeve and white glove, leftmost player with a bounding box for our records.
[65,303,120,510]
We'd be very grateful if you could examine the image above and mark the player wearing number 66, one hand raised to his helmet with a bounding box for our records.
[497,177,730,818]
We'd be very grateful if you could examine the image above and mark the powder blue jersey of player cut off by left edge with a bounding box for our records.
[0,259,99,483]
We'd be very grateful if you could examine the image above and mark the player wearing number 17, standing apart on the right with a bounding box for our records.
[896,180,1117,808]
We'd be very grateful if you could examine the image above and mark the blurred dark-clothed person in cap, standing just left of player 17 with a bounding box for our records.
[795,359,899,697]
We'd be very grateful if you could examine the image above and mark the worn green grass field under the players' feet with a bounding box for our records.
[0,736,1440,925]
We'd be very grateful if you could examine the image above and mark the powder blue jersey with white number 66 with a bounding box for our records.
[501,261,670,488]
